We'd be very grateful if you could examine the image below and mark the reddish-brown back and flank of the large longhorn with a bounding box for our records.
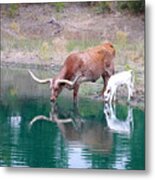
[63,44,115,80]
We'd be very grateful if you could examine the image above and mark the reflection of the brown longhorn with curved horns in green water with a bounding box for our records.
[29,106,113,153]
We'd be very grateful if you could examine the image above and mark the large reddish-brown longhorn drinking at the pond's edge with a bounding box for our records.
[29,42,115,102]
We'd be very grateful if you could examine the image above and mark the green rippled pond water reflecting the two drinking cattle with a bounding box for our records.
[0,69,145,170]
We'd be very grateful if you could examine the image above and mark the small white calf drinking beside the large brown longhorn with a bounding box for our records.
[104,70,134,103]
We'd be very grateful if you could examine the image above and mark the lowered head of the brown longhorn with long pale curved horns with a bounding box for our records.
[28,70,77,102]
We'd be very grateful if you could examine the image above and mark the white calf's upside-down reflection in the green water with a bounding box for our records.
[104,103,134,137]
